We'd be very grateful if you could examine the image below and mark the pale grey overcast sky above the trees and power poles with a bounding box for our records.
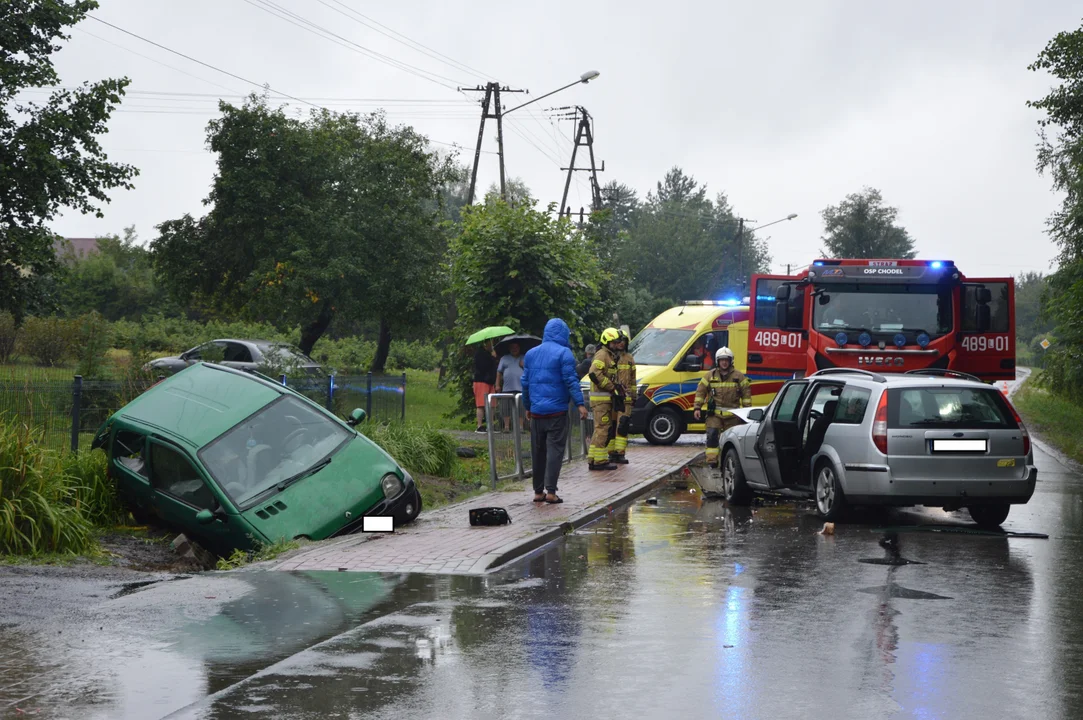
[38,0,1083,276]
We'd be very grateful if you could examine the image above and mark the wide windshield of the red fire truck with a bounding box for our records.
[812,283,952,337]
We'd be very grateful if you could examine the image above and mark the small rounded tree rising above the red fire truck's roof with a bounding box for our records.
[820,187,917,259]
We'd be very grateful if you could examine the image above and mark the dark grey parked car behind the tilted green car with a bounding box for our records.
[146,339,324,376]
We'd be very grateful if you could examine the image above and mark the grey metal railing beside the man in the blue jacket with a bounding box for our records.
[485,393,593,489]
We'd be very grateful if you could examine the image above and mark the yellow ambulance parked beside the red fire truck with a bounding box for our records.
[584,300,794,445]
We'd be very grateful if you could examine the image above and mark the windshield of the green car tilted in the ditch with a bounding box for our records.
[199,395,352,507]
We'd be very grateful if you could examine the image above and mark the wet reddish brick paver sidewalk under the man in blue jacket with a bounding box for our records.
[271,445,702,575]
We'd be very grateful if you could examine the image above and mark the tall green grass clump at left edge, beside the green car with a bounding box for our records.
[0,420,94,554]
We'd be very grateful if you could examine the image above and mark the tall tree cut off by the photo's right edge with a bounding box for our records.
[1028,22,1083,402]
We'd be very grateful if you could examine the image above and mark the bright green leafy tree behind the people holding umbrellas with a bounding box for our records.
[449,198,610,411]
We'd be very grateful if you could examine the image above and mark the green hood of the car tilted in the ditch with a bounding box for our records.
[243,428,403,542]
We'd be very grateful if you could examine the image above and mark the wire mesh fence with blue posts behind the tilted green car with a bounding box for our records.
[0,374,406,450]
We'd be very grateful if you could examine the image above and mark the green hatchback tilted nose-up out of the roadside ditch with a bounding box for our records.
[94,363,421,554]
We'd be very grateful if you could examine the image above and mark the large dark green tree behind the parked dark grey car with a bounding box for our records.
[152,97,454,372]
